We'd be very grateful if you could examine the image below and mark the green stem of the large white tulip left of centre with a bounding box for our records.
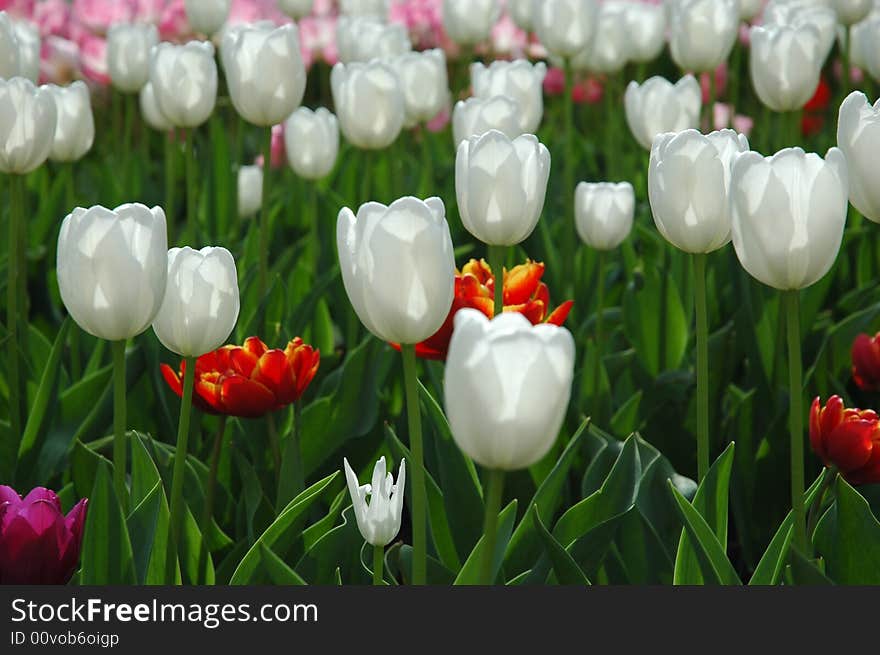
[400,344,428,585]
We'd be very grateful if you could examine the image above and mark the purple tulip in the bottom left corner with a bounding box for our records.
[0,485,89,584]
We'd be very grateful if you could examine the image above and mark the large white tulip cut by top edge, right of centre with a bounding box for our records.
[669,0,739,73]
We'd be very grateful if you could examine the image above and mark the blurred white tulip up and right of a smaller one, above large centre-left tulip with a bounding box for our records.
[330,61,406,150]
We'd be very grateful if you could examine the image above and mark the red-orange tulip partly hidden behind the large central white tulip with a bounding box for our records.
[395,259,574,360]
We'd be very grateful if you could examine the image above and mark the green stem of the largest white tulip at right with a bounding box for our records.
[784,289,807,553]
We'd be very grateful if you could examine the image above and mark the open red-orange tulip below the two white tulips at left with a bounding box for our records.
[162,337,321,418]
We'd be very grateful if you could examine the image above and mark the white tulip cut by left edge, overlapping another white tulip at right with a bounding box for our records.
[0,77,58,174]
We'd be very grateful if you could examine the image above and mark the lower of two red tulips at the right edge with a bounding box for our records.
[810,396,880,484]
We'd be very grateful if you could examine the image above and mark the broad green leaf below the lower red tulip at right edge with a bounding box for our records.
[813,476,880,585]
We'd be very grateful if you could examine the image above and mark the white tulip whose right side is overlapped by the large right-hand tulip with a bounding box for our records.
[648,130,749,254]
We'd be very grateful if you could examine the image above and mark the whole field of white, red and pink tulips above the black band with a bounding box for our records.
[0,0,880,586]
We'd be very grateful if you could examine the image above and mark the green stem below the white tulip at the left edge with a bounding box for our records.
[6,175,23,439]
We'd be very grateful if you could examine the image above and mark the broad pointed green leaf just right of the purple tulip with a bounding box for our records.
[80,462,137,585]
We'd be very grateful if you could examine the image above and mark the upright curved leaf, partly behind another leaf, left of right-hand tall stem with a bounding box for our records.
[673,443,734,585]
